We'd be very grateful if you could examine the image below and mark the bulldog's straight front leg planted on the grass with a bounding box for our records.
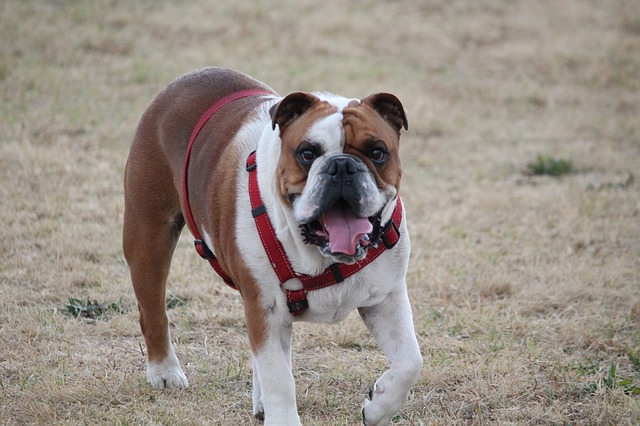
[249,313,301,425]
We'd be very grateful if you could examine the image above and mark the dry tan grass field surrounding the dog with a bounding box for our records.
[0,0,640,425]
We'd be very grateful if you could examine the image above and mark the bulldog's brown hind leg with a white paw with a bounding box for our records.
[123,147,188,388]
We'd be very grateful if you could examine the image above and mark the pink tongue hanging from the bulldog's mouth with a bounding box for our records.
[323,203,373,255]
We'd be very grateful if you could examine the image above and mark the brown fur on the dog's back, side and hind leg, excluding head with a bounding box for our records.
[123,68,272,361]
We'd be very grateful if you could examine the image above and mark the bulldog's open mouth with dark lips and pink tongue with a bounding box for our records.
[300,198,381,263]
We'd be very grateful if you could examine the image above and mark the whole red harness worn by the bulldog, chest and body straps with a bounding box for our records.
[183,91,402,316]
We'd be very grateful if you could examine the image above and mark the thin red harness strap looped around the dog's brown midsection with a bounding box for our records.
[182,89,272,290]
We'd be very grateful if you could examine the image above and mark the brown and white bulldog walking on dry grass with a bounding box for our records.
[123,68,422,425]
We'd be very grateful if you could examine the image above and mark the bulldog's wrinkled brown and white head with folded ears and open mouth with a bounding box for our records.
[271,92,408,263]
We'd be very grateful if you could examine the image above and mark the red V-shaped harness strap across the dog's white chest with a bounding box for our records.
[247,151,402,316]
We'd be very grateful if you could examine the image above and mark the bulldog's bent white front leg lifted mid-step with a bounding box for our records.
[358,288,422,426]
